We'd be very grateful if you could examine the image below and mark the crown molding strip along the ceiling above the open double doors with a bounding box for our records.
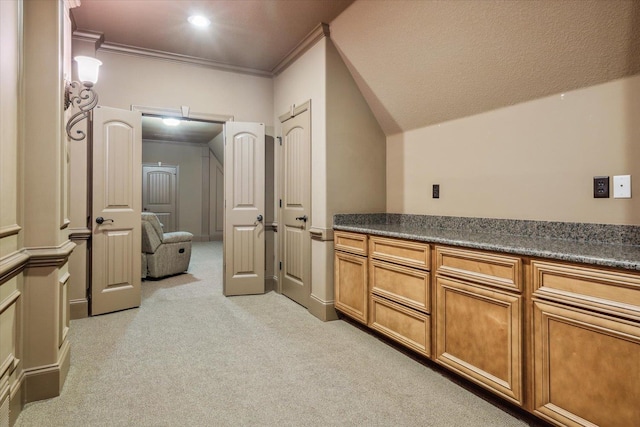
[99,42,271,77]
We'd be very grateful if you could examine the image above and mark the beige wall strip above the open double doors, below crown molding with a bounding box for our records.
[90,50,273,126]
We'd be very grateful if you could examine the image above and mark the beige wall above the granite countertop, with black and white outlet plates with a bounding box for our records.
[387,76,640,224]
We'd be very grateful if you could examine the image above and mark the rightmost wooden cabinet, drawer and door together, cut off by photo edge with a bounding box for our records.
[532,261,640,426]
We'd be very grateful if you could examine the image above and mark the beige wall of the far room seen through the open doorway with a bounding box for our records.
[142,141,215,240]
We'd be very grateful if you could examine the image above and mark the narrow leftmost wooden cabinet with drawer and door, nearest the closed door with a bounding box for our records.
[334,231,369,324]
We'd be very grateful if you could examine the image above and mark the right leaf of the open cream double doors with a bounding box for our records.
[223,122,265,296]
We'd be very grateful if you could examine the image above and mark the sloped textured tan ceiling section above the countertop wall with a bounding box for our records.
[331,0,640,135]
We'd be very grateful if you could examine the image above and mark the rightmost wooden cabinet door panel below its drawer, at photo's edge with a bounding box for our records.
[534,301,640,427]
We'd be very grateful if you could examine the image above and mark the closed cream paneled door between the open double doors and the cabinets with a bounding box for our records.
[281,103,311,307]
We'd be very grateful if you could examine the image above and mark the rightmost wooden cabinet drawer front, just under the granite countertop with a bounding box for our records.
[531,260,640,320]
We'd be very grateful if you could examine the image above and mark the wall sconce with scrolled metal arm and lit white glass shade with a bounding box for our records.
[64,56,102,141]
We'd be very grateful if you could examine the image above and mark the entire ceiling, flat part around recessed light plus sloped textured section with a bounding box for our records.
[72,0,640,135]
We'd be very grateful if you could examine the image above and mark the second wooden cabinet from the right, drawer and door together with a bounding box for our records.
[435,246,523,405]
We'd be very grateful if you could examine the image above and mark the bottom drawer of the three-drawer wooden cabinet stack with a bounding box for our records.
[369,294,431,357]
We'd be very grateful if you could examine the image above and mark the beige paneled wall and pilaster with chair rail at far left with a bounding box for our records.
[0,0,74,425]
